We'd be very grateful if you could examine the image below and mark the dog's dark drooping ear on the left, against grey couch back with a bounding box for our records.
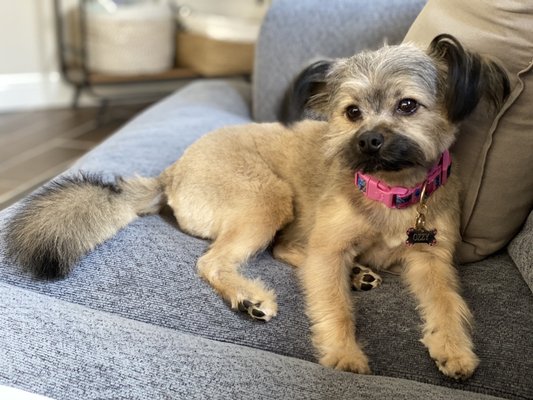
[280,60,334,125]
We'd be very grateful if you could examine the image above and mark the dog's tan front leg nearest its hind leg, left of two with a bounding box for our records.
[298,198,370,374]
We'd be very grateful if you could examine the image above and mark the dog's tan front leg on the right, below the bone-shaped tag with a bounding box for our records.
[404,249,479,379]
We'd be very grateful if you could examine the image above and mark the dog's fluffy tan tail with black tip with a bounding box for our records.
[6,174,164,278]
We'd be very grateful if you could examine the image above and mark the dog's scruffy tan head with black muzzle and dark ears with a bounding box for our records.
[282,35,509,181]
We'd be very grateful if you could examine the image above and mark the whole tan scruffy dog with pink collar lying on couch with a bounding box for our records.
[6,34,509,379]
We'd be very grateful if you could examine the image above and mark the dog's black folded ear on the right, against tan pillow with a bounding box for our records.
[428,34,509,122]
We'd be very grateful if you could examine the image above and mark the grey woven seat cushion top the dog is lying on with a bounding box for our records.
[0,219,533,398]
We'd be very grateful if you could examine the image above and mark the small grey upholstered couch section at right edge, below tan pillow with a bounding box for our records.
[507,211,533,292]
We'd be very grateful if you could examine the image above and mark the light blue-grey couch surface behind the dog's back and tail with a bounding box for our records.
[68,80,251,179]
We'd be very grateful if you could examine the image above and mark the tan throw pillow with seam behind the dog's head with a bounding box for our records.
[405,0,533,261]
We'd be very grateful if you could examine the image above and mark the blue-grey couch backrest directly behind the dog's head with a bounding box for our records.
[252,0,425,122]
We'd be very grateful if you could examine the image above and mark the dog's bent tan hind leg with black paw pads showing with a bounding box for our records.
[197,209,292,321]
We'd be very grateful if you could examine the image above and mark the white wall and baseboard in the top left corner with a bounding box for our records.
[0,0,76,112]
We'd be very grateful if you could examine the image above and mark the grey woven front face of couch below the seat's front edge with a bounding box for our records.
[0,284,500,400]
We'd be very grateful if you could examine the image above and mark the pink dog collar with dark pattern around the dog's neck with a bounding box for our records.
[355,150,452,208]
